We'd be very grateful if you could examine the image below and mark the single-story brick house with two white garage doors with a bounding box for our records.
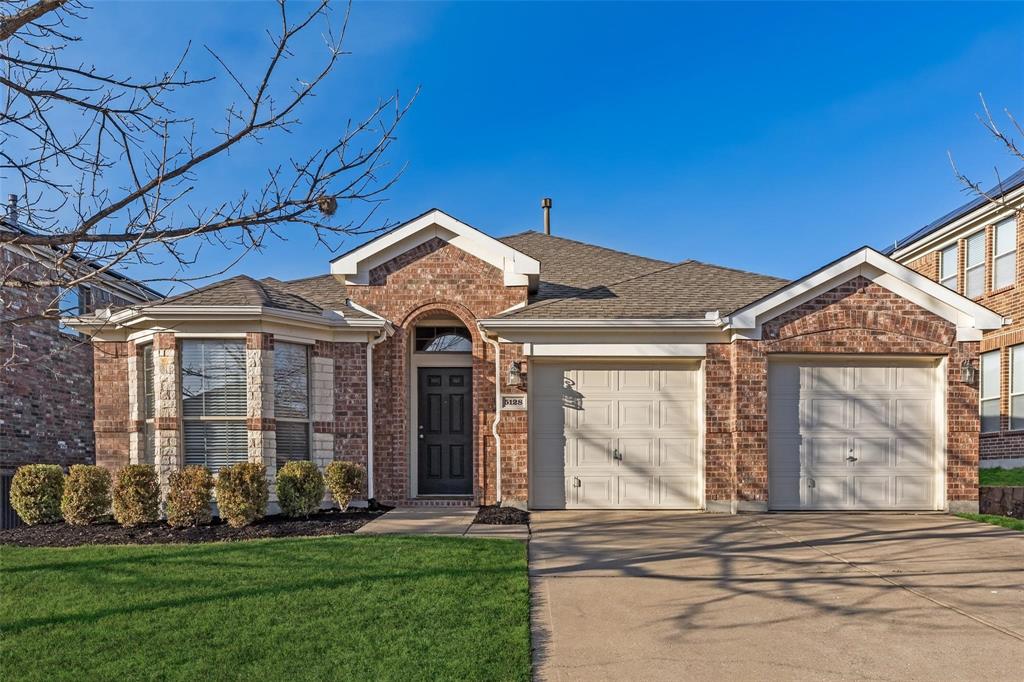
[70,204,1002,512]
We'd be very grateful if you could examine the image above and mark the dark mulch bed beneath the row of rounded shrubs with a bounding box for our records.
[0,507,387,547]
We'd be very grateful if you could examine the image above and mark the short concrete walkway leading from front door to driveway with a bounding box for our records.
[355,507,529,540]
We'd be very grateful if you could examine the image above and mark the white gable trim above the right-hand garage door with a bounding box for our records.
[726,247,1002,341]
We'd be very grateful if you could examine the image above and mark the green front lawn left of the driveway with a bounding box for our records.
[0,537,530,682]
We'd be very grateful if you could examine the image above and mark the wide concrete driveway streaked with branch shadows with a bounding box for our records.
[529,512,1024,681]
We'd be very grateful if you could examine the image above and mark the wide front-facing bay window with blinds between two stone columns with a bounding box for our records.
[181,340,249,472]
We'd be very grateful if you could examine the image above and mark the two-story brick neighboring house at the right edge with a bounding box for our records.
[887,169,1024,467]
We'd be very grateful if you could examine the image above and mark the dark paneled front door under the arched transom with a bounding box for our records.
[417,367,473,495]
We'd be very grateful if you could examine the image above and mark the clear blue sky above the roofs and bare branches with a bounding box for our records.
[32,2,1024,286]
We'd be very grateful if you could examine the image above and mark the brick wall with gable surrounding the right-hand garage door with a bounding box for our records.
[706,276,979,509]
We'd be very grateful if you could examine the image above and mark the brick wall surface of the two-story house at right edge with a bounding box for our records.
[906,209,1024,460]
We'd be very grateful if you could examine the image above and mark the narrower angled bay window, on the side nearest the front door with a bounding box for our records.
[273,343,310,469]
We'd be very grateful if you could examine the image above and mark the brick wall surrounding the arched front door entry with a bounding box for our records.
[348,239,526,502]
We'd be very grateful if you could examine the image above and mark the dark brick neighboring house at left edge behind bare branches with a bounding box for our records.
[0,217,160,475]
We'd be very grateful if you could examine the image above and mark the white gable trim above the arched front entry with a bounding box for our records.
[331,209,541,287]
